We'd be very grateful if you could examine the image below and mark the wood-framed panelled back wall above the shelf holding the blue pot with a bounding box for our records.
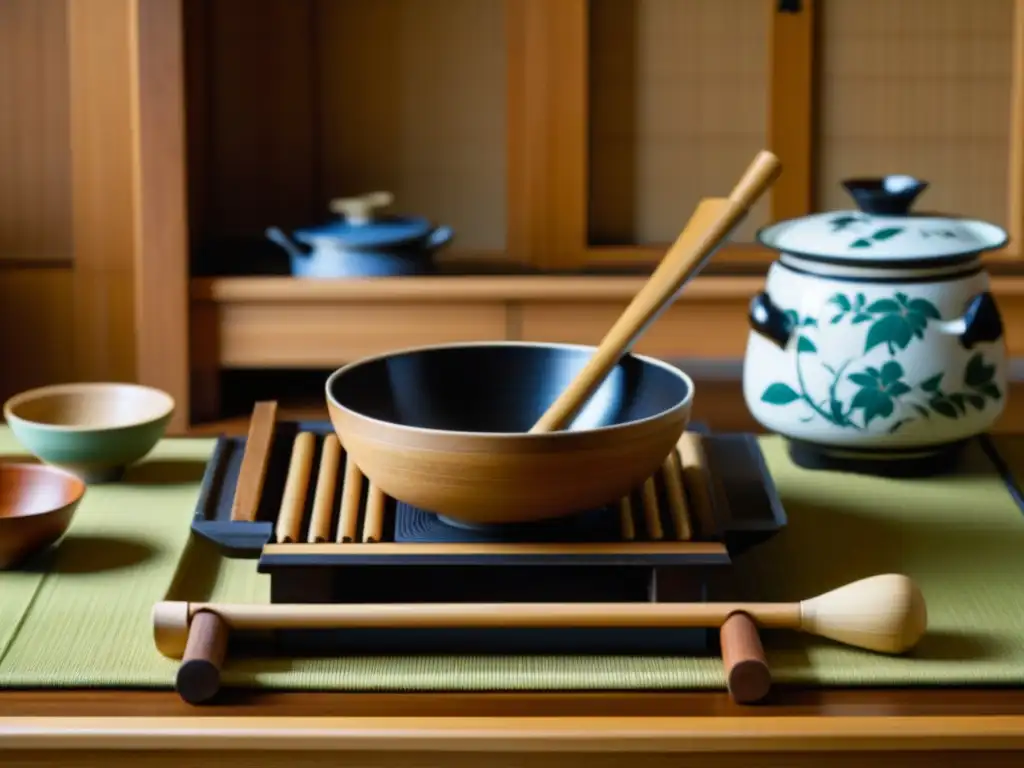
[178,0,1024,269]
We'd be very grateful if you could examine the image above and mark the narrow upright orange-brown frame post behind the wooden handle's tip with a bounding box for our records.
[768,0,815,221]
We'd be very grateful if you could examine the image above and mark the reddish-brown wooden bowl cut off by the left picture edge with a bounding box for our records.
[0,464,85,568]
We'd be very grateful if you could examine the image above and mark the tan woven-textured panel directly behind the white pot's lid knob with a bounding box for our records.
[815,0,1014,225]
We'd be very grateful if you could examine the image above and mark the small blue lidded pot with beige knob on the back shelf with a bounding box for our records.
[266,193,454,278]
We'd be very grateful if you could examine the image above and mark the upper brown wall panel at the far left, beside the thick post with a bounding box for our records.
[0,0,72,262]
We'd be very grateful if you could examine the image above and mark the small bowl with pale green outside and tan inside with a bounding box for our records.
[3,383,174,483]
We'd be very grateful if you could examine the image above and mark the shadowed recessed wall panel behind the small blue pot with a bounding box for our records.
[184,0,506,259]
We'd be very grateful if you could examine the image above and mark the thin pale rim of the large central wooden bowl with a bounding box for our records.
[324,341,695,440]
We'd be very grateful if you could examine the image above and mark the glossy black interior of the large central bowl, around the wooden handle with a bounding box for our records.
[330,345,689,432]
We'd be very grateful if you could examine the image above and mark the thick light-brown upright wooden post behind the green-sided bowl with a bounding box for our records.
[68,0,189,429]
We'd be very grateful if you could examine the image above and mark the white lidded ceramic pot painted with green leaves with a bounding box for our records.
[743,176,1007,472]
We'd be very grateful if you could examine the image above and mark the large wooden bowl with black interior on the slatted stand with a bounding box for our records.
[327,342,693,524]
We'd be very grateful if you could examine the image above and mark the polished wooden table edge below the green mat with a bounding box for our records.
[0,421,1024,768]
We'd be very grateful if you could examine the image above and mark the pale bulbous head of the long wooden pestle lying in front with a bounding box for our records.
[800,573,928,653]
